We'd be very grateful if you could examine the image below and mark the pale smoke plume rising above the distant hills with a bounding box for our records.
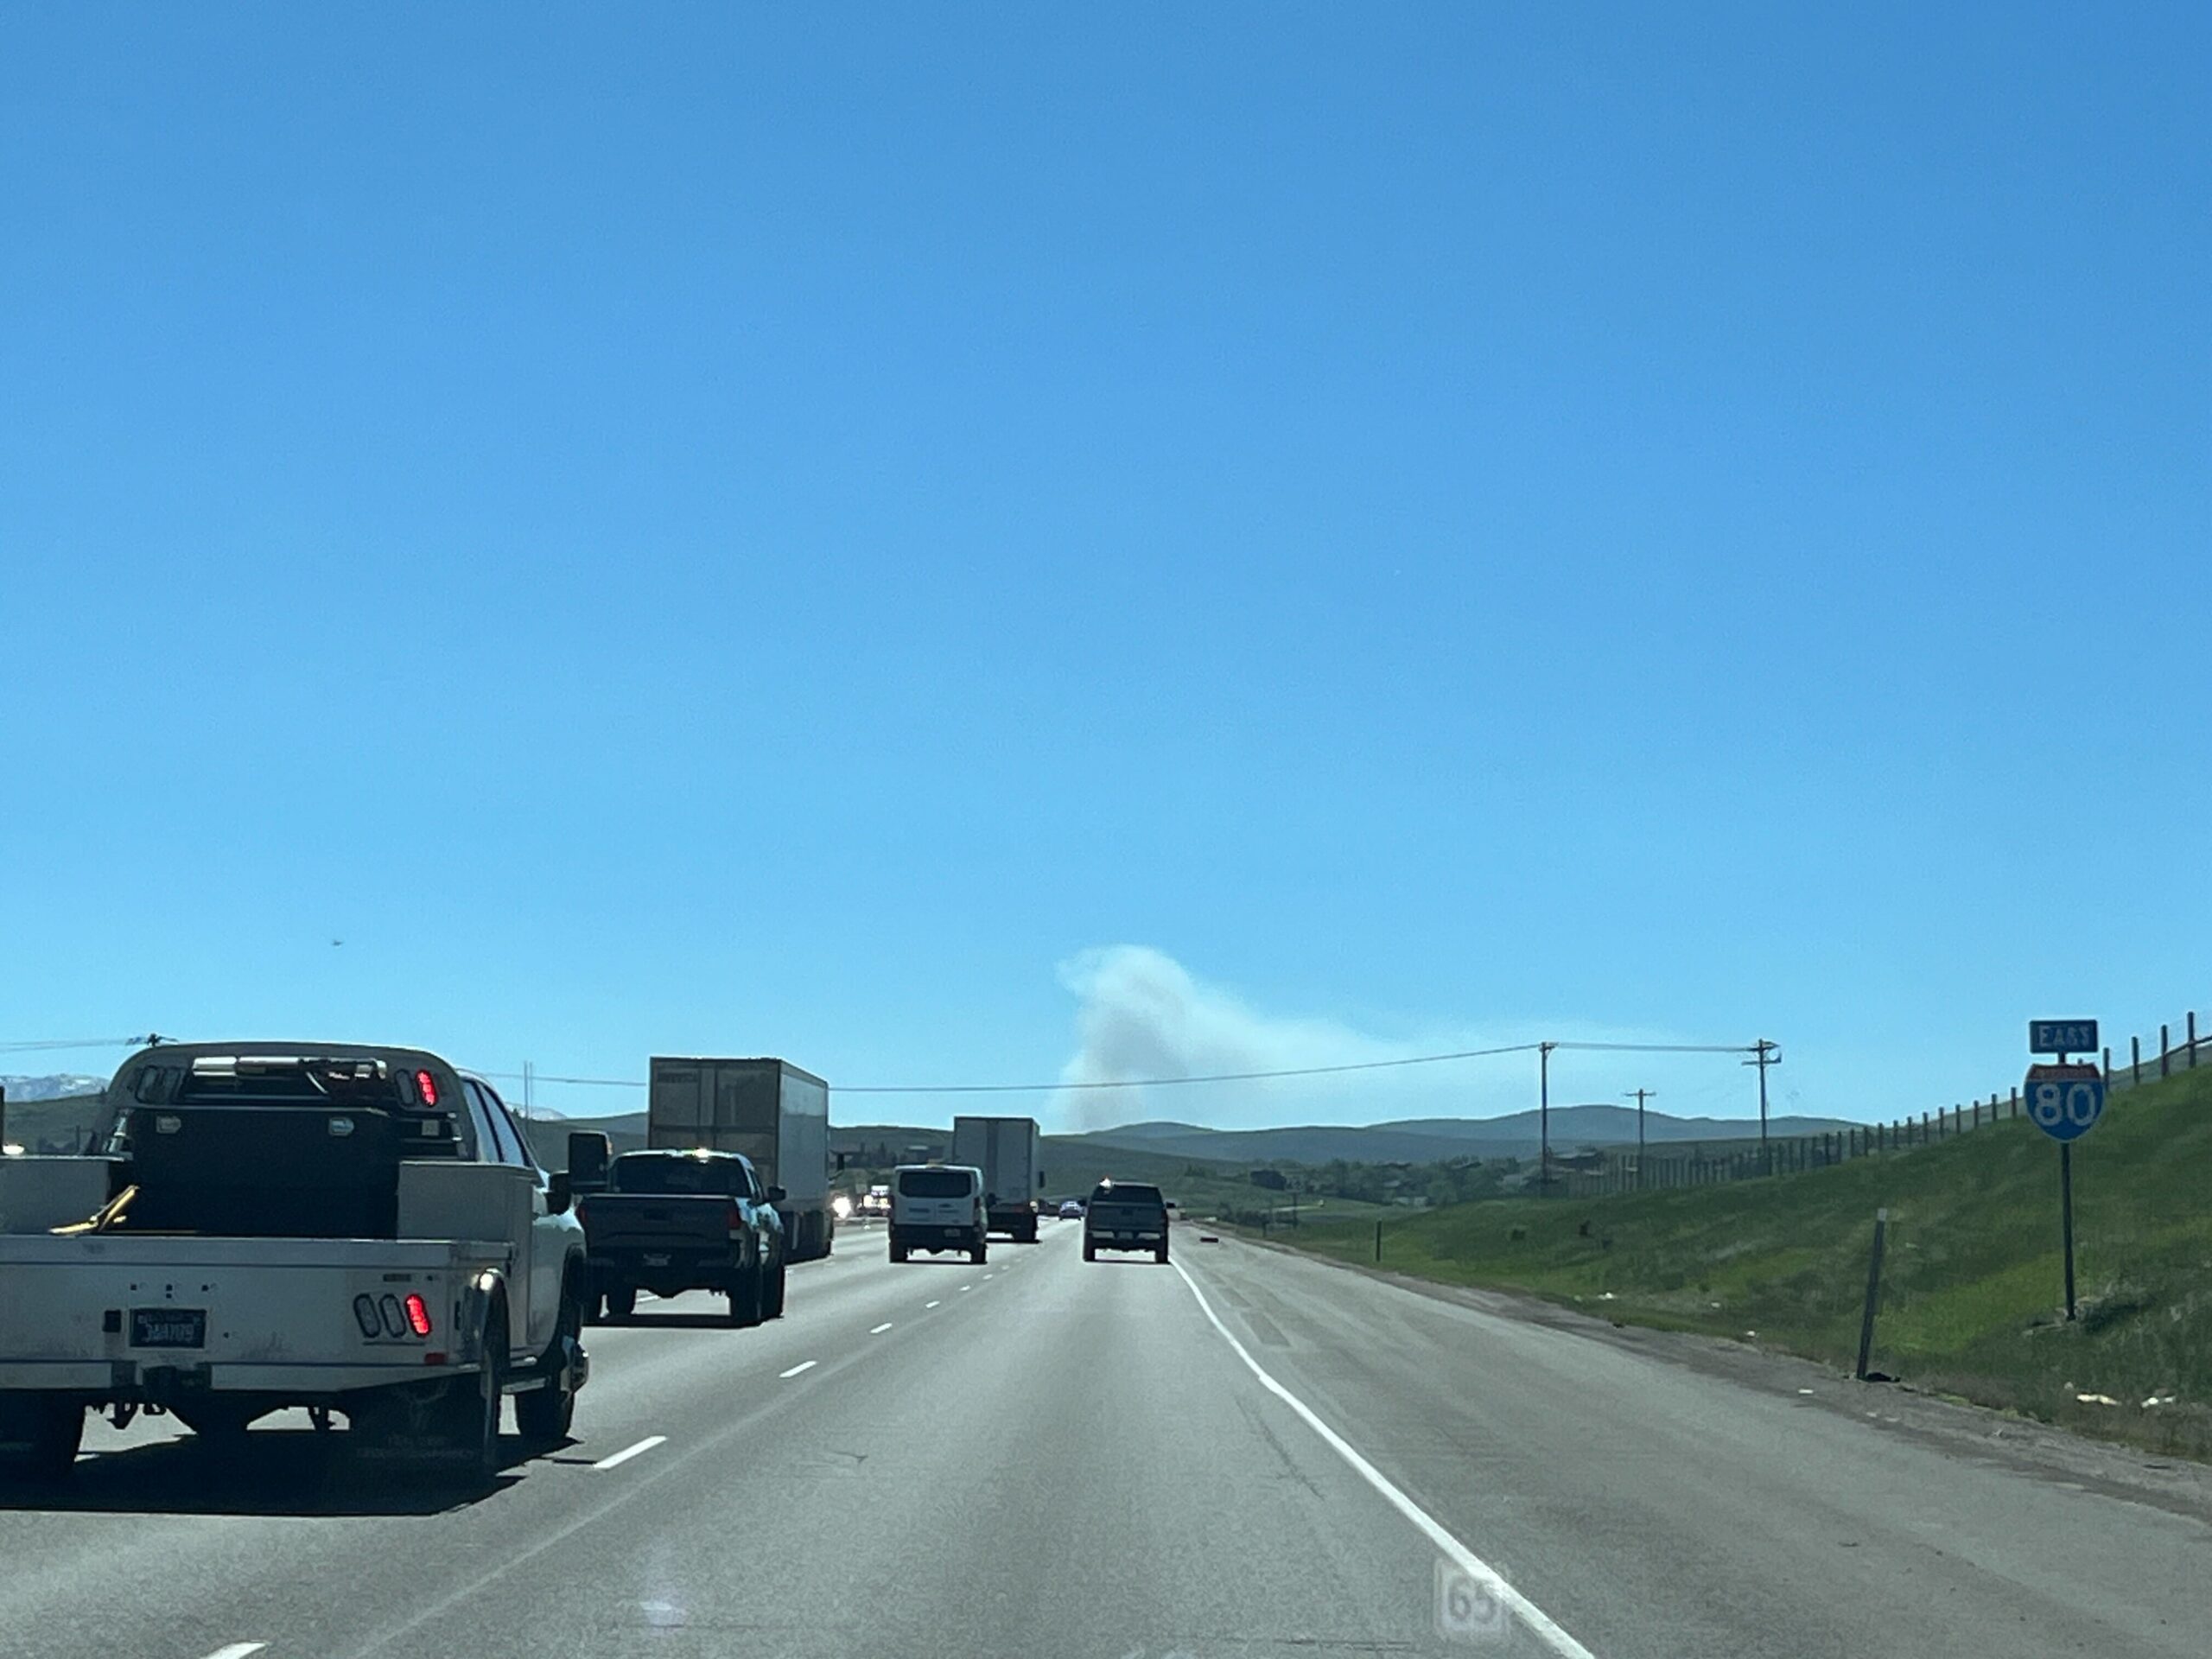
[1048,944,1405,1130]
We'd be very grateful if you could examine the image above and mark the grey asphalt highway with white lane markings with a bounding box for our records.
[0,1224,2212,1659]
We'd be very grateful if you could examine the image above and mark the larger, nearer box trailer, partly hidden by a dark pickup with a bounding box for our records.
[646,1055,836,1261]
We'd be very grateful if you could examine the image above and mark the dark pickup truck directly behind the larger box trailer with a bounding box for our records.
[577,1150,785,1325]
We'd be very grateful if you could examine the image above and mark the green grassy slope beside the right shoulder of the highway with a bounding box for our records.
[1276,1068,2212,1458]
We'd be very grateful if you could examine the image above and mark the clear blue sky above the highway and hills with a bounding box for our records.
[0,4,2212,1123]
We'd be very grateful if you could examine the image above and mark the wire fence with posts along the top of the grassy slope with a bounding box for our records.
[1529,1008,2212,1199]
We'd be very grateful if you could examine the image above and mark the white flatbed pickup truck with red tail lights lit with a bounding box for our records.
[0,1042,591,1480]
